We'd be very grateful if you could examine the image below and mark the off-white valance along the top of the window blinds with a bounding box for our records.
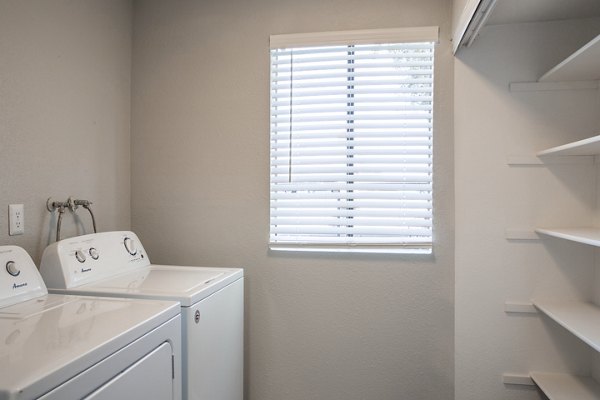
[270,26,439,49]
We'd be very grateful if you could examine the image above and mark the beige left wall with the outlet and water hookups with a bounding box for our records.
[0,0,131,261]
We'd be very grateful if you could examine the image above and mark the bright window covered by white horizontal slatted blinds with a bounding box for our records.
[270,27,438,253]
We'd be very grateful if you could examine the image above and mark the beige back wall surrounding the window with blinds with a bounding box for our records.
[131,0,454,400]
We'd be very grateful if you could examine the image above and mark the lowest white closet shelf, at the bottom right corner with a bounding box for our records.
[530,372,600,400]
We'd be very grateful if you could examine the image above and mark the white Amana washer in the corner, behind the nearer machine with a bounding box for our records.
[40,232,244,400]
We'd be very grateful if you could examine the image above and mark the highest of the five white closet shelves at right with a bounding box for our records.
[538,35,600,82]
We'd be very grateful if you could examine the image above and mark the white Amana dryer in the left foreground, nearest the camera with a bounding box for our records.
[0,246,181,400]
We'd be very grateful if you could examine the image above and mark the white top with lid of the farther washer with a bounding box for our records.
[51,265,243,307]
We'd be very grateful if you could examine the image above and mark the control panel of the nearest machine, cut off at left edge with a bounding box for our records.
[0,246,48,307]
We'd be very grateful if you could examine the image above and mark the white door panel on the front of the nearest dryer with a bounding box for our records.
[85,343,173,400]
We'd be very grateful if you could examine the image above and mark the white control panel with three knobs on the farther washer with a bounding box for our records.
[40,231,150,289]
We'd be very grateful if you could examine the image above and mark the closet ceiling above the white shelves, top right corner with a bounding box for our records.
[486,0,600,25]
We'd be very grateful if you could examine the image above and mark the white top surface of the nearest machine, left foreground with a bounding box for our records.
[0,294,180,398]
